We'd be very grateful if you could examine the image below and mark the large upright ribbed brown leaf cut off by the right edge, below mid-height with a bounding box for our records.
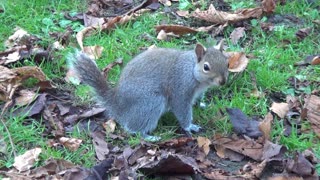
[304,95,320,138]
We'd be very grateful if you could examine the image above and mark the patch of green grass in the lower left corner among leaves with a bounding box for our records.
[0,107,95,168]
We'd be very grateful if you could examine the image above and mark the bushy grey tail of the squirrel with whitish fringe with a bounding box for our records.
[68,51,112,104]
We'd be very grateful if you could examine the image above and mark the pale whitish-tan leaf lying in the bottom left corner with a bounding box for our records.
[13,148,42,172]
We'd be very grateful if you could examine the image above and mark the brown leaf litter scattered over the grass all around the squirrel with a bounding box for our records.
[0,0,320,179]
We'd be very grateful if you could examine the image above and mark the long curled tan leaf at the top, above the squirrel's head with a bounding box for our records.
[191,4,262,24]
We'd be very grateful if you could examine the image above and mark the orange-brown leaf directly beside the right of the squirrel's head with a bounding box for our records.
[225,52,249,72]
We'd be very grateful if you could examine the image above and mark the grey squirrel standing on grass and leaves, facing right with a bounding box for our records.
[68,41,228,141]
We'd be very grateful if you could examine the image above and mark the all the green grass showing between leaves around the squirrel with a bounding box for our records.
[0,0,320,175]
